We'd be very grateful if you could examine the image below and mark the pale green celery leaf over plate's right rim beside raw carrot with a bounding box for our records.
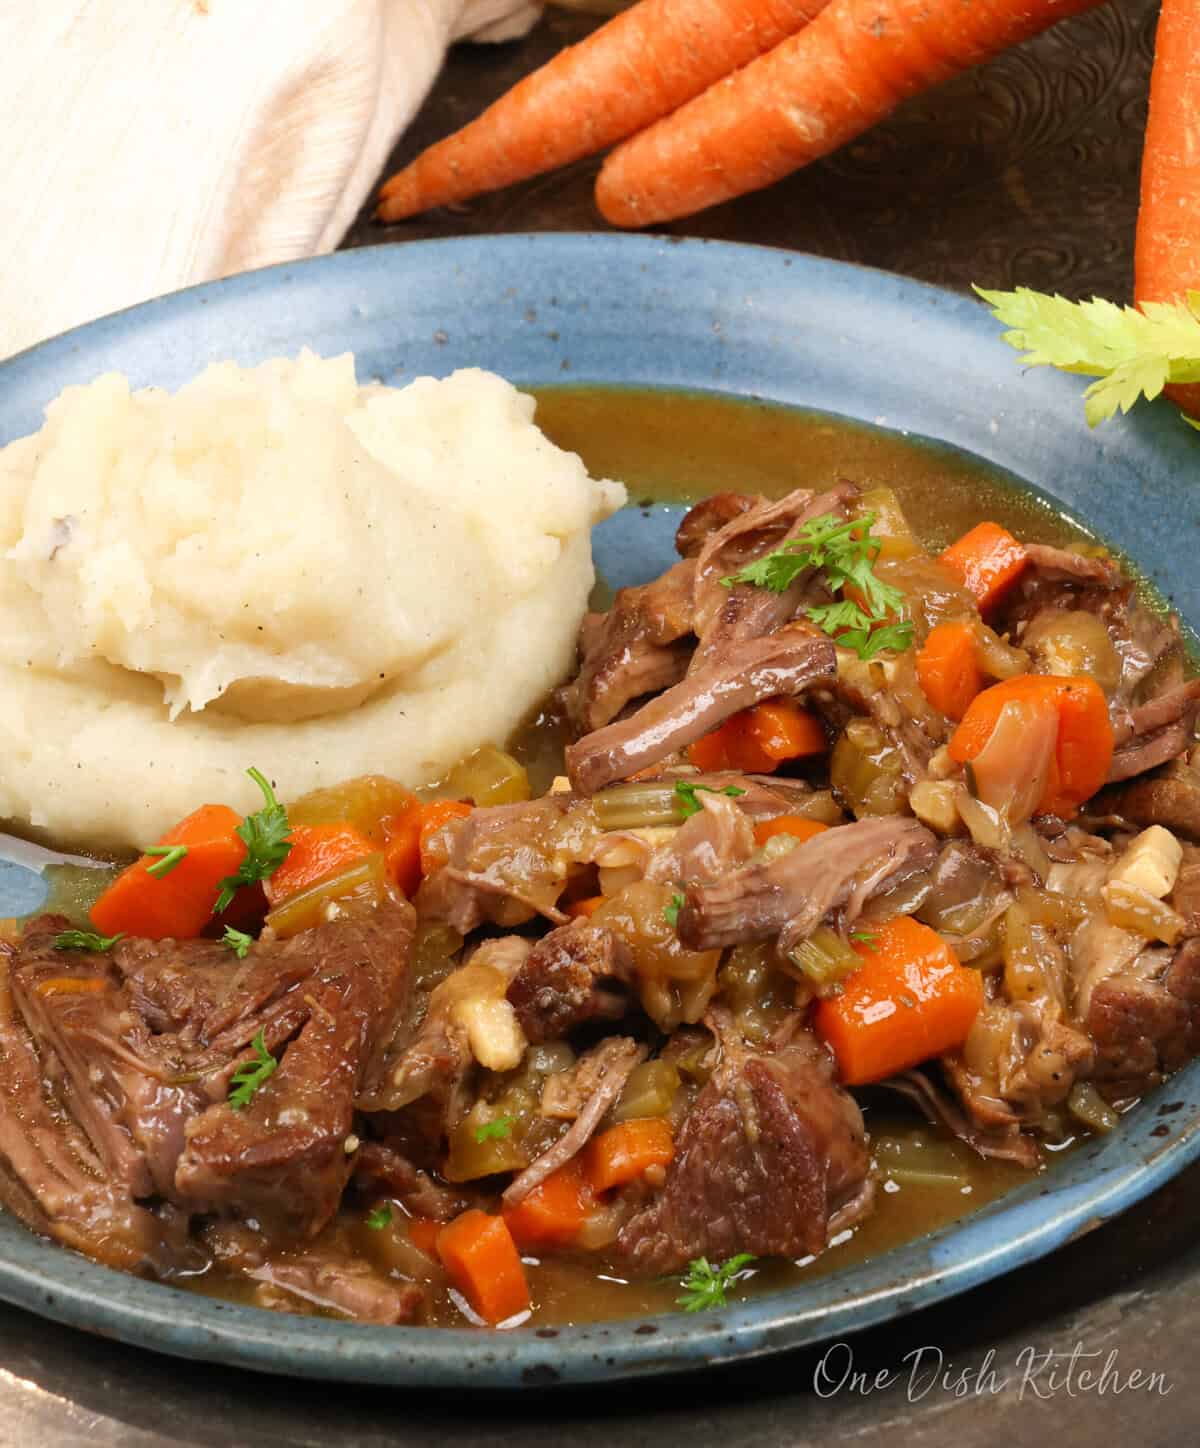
[976,287,1200,427]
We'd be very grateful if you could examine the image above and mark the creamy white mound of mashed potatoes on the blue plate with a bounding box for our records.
[0,353,624,846]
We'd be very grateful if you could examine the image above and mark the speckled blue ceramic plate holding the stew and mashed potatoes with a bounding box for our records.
[0,235,1200,1387]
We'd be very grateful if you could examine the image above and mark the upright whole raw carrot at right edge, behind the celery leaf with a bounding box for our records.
[1133,0,1200,416]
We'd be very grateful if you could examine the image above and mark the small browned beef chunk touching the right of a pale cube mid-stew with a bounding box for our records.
[508,921,634,1043]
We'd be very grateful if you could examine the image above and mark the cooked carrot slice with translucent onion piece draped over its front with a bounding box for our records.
[950,673,1113,817]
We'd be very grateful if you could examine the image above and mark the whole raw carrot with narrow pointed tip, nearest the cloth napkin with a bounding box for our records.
[378,0,828,222]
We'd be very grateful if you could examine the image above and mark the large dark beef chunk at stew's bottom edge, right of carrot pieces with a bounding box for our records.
[617,1032,871,1276]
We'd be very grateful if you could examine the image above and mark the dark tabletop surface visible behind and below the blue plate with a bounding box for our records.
[0,0,1200,1448]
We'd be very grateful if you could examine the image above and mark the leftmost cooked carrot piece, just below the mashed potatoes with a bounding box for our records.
[91,805,246,940]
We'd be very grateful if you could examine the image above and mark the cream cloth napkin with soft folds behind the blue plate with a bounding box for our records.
[0,0,540,358]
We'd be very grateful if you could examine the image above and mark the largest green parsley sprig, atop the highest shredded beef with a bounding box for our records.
[721,513,912,659]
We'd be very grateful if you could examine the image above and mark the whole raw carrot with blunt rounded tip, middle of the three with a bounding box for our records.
[596,0,1102,226]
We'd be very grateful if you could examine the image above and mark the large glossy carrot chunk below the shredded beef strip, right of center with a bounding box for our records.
[814,915,983,1086]
